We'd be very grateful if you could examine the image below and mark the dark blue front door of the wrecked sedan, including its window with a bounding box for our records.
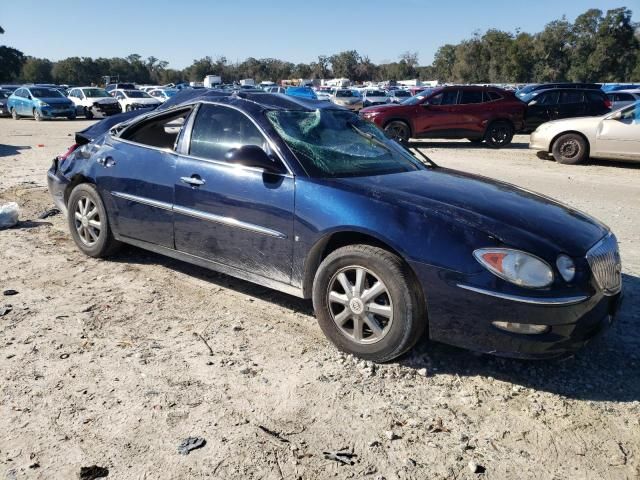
[174,104,295,283]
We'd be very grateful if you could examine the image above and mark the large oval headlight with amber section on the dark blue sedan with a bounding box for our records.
[473,248,553,288]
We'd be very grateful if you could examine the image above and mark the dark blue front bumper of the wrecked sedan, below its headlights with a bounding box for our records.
[412,264,622,359]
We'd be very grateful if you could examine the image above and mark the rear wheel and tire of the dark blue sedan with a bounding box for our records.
[67,183,120,258]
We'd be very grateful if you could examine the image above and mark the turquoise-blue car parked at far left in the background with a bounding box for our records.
[7,87,76,121]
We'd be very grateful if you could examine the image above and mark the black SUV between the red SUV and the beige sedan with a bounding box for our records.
[524,88,611,132]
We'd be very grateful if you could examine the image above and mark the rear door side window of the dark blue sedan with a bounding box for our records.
[120,108,191,150]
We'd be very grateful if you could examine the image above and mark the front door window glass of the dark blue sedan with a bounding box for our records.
[189,104,267,161]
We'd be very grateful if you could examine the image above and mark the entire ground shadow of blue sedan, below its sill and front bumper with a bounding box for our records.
[109,246,640,402]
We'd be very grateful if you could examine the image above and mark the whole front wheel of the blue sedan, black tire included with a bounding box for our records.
[313,245,427,362]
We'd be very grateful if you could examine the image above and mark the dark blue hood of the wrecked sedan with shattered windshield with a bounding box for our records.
[336,168,609,257]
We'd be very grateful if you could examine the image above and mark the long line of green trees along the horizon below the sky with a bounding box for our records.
[0,7,640,85]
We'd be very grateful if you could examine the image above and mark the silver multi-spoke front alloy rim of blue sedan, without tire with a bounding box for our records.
[327,266,393,344]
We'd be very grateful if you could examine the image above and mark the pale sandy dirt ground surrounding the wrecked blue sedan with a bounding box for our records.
[0,119,640,480]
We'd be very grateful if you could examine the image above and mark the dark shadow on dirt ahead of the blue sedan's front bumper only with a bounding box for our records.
[398,274,640,402]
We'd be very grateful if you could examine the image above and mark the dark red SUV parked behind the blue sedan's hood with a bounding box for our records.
[360,86,526,148]
